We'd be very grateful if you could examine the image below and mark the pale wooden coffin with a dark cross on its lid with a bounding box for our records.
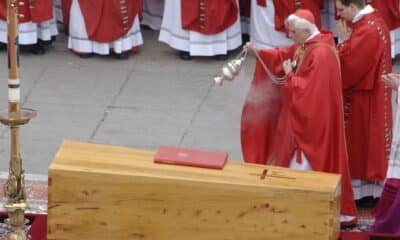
[48,141,340,240]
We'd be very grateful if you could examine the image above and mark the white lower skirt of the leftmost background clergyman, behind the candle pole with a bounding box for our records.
[0,11,58,45]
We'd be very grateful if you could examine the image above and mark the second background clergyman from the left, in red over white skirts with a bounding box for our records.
[62,0,143,58]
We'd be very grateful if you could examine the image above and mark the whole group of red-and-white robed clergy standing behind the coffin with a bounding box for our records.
[0,0,400,234]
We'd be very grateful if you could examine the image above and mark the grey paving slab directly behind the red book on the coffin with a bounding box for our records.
[93,108,192,150]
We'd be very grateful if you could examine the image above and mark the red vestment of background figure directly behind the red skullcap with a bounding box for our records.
[257,0,323,32]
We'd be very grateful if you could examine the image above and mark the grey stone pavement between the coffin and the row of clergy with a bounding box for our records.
[0,29,254,175]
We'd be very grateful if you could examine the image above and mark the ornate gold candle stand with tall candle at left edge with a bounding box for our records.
[0,0,36,240]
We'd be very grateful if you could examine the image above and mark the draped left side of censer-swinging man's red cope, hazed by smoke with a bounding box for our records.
[241,48,293,164]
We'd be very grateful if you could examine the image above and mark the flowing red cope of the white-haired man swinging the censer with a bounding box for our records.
[241,32,356,216]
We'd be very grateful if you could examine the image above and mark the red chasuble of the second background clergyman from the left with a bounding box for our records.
[62,0,143,43]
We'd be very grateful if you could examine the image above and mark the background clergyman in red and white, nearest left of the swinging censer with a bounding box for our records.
[159,0,242,60]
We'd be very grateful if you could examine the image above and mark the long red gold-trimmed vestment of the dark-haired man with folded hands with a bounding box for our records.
[338,12,392,181]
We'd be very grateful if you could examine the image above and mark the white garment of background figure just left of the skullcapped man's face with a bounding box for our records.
[250,0,293,49]
